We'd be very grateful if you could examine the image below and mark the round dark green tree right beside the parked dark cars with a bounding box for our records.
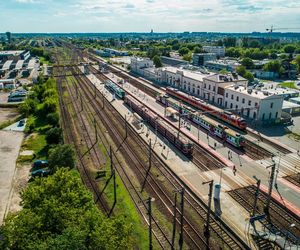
[49,144,75,169]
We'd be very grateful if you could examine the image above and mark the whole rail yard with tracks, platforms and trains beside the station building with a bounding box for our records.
[41,43,300,249]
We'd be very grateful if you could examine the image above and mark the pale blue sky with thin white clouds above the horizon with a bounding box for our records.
[0,0,300,33]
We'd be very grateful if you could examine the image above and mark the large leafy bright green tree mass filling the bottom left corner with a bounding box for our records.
[0,168,133,250]
